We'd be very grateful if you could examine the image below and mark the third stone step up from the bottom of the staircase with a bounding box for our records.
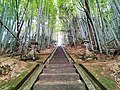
[43,68,76,73]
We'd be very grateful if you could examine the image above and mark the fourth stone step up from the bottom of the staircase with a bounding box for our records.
[45,64,74,68]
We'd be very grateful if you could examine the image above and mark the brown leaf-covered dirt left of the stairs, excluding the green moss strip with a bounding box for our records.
[0,48,54,83]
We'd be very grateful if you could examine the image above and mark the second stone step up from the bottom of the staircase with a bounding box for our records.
[39,73,80,81]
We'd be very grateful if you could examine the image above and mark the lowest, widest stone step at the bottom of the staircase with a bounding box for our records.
[33,80,86,90]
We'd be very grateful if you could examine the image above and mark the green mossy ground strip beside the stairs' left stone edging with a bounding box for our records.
[0,63,35,90]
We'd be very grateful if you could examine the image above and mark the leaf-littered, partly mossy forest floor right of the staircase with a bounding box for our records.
[65,46,120,90]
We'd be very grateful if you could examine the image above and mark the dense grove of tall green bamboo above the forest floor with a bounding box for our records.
[0,0,120,57]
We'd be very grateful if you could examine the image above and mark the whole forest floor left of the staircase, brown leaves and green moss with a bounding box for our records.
[0,47,54,90]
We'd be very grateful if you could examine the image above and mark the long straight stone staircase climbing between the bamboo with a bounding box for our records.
[33,47,86,90]
